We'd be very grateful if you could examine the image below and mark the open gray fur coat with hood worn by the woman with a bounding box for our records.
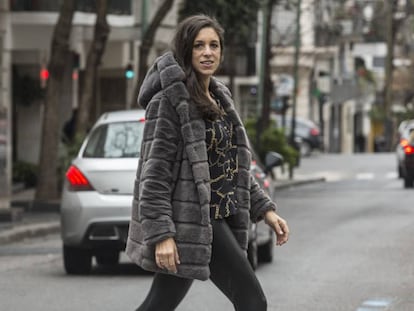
[126,52,276,280]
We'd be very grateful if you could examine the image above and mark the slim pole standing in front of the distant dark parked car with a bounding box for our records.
[290,0,302,145]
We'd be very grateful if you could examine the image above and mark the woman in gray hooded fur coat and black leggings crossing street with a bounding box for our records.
[126,15,289,311]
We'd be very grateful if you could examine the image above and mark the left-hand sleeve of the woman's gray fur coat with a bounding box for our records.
[134,95,180,245]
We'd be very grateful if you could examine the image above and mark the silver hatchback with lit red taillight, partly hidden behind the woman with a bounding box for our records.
[61,110,281,274]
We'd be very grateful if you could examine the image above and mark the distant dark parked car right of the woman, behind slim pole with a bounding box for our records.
[272,114,323,156]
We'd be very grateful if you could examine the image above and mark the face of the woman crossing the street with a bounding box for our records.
[192,27,221,82]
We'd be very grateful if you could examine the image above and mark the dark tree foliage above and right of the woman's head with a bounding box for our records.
[179,0,260,89]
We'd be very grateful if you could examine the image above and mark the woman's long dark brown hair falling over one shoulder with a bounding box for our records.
[172,14,224,120]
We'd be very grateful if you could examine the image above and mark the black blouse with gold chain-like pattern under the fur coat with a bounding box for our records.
[205,97,238,219]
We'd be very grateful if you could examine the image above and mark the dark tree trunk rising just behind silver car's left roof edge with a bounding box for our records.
[75,0,110,141]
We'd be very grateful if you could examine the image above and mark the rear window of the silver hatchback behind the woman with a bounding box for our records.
[83,122,144,158]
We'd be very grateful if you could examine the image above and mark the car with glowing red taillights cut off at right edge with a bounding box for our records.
[396,124,414,188]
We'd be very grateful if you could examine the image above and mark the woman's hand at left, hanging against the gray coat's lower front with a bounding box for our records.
[155,238,180,273]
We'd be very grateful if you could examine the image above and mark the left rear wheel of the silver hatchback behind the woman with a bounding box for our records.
[63,246,92,274]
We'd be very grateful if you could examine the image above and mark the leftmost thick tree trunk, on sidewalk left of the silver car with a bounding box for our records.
[35,0,76,200]
